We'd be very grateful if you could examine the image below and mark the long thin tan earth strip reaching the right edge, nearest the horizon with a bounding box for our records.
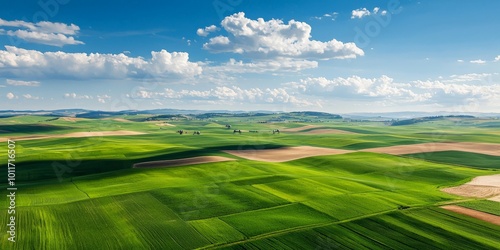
[361,142,500,156]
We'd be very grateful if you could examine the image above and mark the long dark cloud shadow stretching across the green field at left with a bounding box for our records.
[0,144,285,185]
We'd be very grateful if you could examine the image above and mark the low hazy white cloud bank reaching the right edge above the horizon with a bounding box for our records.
[290,74,500,106]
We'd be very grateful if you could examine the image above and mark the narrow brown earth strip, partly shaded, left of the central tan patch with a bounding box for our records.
[133,156,235,168]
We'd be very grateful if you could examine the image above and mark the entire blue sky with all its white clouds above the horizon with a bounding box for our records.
[0,0,500,113]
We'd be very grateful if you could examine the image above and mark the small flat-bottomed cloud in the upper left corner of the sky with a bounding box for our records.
[0,18,84,47]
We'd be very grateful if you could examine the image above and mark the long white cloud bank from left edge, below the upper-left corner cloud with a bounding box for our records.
[0,46,202,79]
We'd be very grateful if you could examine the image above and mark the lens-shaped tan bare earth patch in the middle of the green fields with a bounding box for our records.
[224,146,353,162]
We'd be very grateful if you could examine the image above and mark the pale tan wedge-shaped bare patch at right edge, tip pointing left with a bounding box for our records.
[441,174,500,201]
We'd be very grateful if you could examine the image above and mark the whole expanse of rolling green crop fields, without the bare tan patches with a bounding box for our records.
[0,114,500,250]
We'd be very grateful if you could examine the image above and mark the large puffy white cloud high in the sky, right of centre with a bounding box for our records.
[203,12,364,59]
